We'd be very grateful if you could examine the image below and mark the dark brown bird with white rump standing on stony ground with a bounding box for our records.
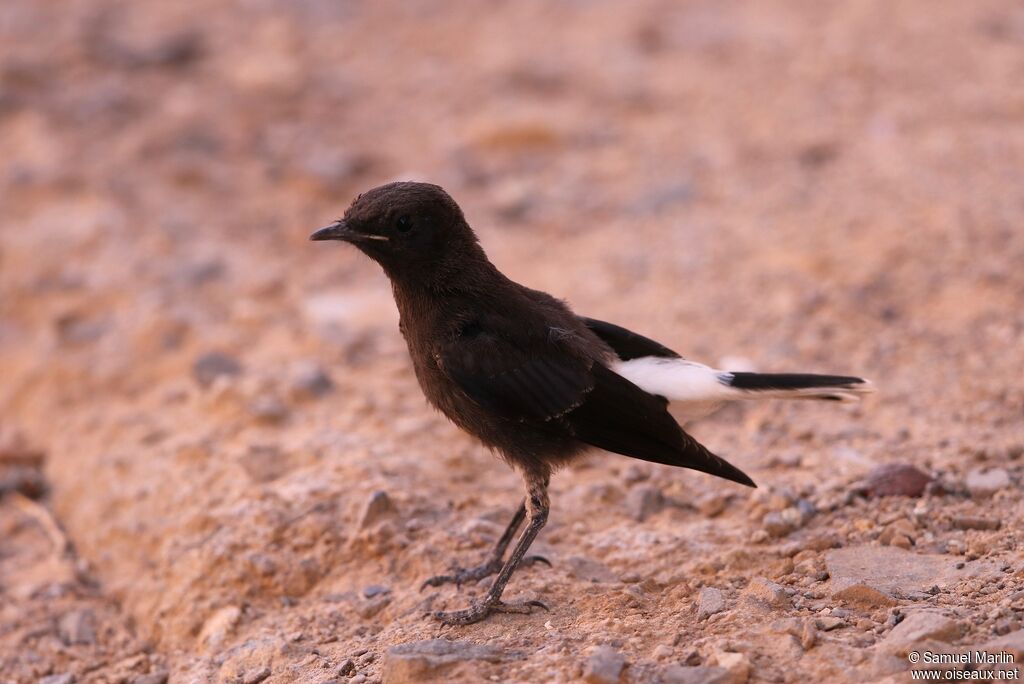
[310,181,873,625]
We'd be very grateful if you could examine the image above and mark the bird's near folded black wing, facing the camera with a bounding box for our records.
[438,334,755,486]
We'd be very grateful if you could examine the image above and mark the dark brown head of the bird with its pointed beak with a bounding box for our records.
[309,182,482,281]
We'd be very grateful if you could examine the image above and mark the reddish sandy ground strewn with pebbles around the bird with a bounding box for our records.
[0,0,1024,684]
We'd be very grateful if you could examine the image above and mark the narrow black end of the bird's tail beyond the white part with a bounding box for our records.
[719,372,874,402]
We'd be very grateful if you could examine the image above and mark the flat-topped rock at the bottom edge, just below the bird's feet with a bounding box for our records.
[381,639,513,684]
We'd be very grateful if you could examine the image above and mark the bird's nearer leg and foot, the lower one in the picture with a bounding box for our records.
[434,473,550,625]
